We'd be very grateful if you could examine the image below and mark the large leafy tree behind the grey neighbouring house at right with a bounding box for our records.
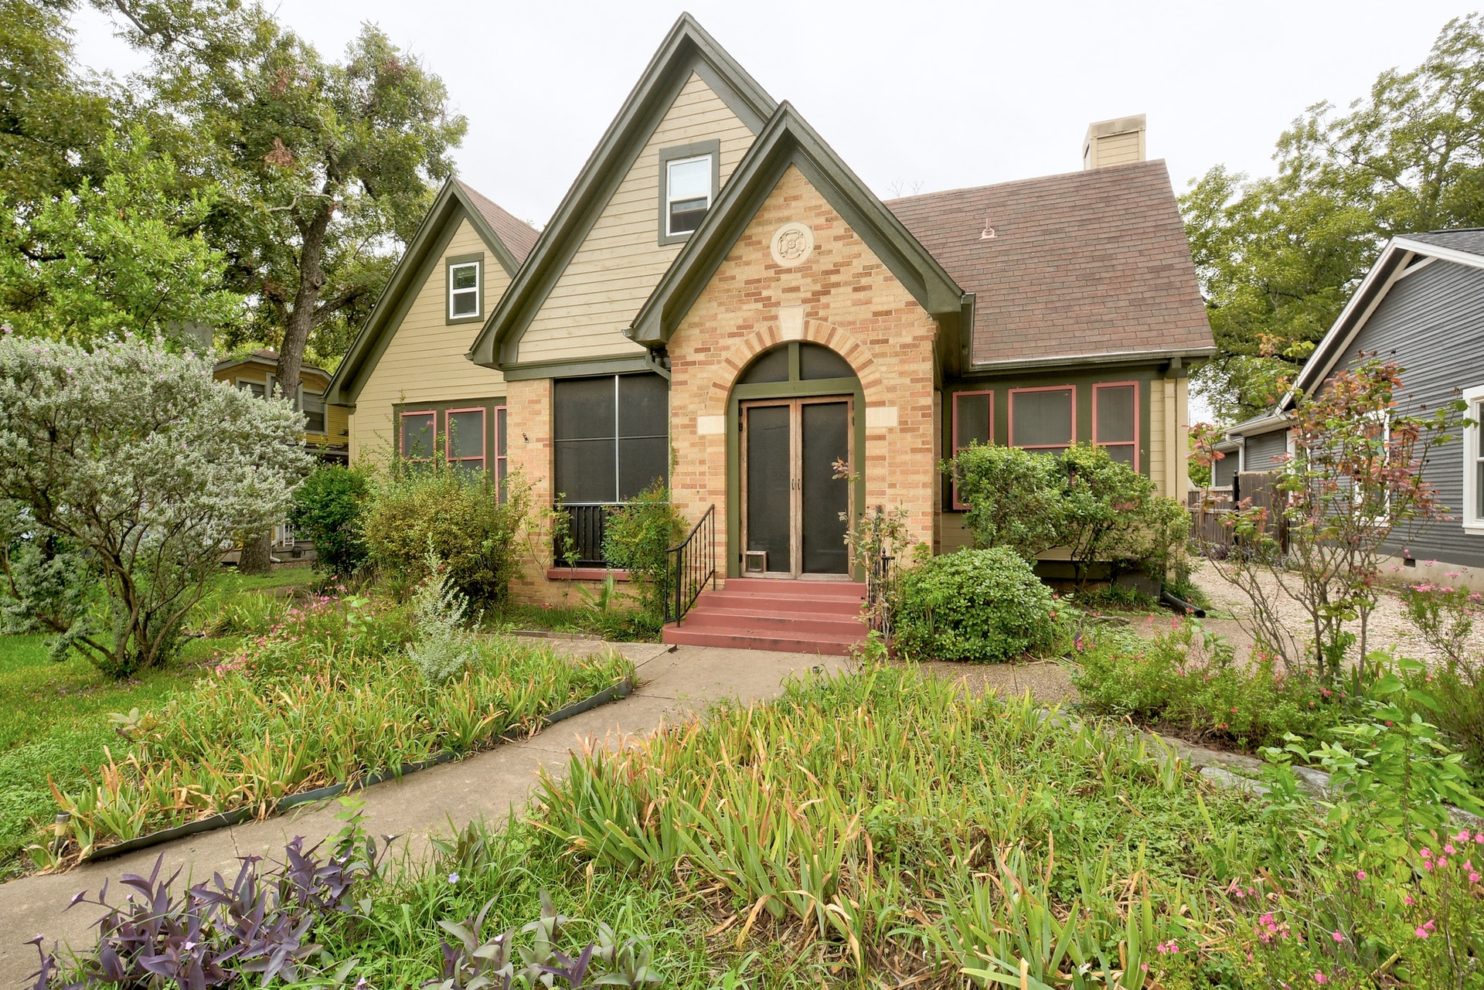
[1181,13,1484,419]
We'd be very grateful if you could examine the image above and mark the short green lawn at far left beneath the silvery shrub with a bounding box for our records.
[0,568,312,879]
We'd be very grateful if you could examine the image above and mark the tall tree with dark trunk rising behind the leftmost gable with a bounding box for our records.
[107,0,466,398]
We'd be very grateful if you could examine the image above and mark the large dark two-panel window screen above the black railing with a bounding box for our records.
[552,374,669,503]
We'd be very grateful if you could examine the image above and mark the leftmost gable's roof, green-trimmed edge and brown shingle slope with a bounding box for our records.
[325,178,539,405]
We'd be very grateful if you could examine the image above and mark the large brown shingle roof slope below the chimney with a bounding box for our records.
[886,162,1212,364]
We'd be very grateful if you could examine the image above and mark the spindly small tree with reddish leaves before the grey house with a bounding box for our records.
[1212,358,1465,678]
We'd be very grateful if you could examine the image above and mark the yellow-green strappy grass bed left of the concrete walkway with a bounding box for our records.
[37,600,634,865]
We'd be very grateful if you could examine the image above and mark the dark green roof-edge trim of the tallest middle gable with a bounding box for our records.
[469,13,776,368]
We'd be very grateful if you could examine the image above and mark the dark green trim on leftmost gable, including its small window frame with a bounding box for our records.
[325,178,519,405]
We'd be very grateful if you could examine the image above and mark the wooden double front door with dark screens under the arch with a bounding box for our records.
[741,396,855,577]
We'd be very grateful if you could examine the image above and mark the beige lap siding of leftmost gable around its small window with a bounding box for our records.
[350,218,509,465]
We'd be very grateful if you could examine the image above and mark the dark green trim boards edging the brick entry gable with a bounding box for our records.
[628,101,972,363]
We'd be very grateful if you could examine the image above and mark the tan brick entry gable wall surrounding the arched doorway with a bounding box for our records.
[669,168,939,584]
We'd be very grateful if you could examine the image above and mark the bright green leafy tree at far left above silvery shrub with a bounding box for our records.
[0,129,242,346]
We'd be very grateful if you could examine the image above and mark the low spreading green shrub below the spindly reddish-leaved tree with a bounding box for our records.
[1071,619,1356,750]
